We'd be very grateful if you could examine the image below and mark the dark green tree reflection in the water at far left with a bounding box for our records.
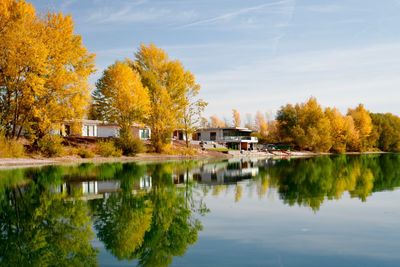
[0,167,97,266]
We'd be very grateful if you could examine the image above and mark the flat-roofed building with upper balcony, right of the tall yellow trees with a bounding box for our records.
[193,127,258,150]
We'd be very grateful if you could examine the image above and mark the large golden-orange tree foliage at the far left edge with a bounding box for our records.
[0,0,94,140]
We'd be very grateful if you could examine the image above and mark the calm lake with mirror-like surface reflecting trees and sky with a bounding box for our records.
[0,154,400,267]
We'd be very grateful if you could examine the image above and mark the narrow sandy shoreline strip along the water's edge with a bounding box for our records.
[0,151,391,169]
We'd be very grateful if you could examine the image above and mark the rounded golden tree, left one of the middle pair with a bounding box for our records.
[93,61,150,135]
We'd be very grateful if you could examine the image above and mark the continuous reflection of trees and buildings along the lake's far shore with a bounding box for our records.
[0,154,400,266]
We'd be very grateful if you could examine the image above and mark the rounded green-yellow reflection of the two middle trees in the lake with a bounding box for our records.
[94,164,206,266]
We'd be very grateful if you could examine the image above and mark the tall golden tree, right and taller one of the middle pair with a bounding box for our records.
[132,44,198,152]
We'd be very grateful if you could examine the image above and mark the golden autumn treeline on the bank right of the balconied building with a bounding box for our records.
[217,97,400,153]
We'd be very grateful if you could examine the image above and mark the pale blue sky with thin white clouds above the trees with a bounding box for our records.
[30,0,400,118]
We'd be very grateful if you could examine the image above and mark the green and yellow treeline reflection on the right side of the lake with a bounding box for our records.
[205,154,400,211]
